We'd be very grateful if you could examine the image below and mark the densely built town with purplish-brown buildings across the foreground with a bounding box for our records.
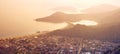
[0,35,120,54]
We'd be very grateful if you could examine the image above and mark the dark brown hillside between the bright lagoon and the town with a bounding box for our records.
[48,24,120,42]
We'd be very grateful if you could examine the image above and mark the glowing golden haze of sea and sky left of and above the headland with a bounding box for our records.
[0,0,120,37]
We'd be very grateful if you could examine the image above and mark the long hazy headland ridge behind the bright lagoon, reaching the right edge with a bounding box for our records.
[36,8,120,25]
